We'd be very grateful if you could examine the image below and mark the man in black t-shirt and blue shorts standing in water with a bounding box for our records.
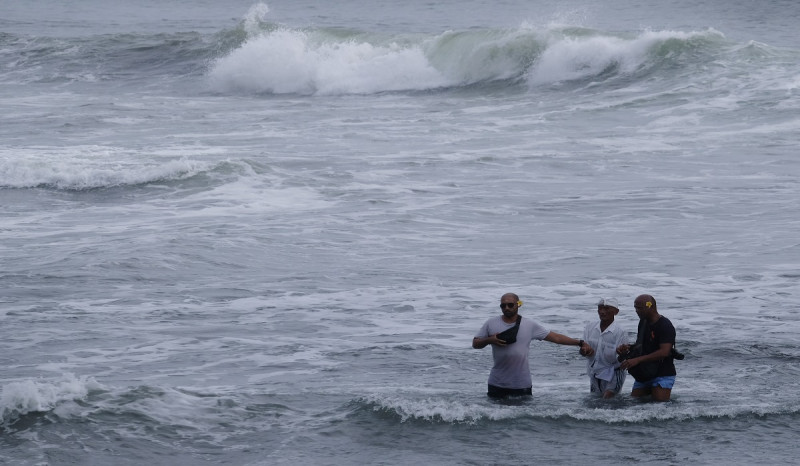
[617,294,677,401]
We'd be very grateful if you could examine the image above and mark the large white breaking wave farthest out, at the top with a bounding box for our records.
[209,6,723,95]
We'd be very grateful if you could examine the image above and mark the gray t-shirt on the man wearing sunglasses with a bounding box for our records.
[475,316,550,388]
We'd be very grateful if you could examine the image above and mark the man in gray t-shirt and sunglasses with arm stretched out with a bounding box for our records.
[472,293,594,398]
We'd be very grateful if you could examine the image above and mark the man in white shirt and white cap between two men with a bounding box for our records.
[581,298,627,398]
